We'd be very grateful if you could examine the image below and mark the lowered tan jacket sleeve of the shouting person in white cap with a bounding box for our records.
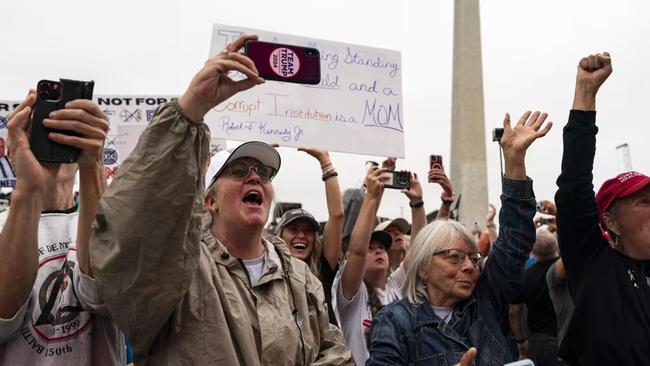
[307,271,354,365]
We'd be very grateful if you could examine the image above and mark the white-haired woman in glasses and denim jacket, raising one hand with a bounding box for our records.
[366,112,551,365]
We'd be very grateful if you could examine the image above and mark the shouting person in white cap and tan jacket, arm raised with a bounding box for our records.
[91,35,352,366]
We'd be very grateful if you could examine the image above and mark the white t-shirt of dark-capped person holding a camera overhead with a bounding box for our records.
[333,264,406,365]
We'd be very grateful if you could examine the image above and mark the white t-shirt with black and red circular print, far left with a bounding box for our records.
[0,212,126,366]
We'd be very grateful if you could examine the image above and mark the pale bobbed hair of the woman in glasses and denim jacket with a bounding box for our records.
[402,219,478,305]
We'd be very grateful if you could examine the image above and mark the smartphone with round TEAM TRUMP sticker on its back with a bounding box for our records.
[244,41,320,85]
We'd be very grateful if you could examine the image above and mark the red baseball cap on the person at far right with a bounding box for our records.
[596,172,650,222]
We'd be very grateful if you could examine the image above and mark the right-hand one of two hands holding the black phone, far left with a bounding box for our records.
[43,99,108,169]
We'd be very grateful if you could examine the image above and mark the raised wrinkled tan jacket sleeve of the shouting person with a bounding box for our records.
[90,102,209,359]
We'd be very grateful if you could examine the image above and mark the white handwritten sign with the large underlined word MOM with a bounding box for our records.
[205,24,405,157]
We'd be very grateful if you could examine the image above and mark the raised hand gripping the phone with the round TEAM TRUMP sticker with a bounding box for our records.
[178,34,264,121]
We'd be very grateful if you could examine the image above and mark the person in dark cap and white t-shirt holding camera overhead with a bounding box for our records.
[334,167,426,365]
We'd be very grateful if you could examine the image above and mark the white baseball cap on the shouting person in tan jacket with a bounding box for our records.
[205,141,281,190]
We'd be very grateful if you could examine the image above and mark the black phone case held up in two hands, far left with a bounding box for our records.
[29,79,95,163]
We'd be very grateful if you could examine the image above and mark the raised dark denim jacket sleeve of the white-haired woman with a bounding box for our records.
[478,177,535,315]
